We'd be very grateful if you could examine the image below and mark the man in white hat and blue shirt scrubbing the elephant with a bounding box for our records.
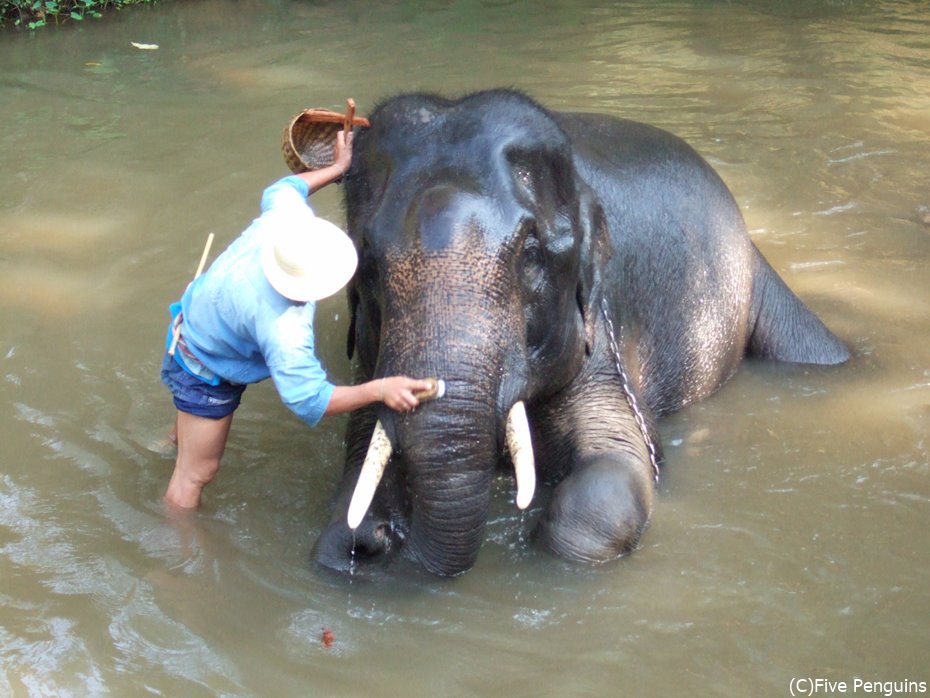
[161,132,430,509]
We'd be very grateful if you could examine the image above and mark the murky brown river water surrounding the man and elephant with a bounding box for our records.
[0,0,930,697]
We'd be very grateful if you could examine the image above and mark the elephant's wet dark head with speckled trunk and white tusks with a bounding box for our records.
[314,91,640,575]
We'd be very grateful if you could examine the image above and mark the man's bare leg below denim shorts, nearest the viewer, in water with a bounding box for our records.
[165,412,232,509]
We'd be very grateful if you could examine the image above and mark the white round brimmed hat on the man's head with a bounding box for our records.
[262,211,358,303]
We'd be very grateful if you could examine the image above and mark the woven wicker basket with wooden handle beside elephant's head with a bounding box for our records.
[281,100,371,174]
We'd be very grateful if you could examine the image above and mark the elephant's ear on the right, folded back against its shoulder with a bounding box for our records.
[576,184,613,355]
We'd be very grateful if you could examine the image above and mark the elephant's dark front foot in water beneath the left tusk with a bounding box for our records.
[310,517,399,574]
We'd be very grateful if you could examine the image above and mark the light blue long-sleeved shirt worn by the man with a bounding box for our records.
[181,176,335,426]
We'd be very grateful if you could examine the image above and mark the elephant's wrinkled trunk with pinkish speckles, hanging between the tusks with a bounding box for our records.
[350,234,531,576]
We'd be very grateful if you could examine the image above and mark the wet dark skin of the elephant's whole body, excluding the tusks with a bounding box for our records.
[313,91,849,575]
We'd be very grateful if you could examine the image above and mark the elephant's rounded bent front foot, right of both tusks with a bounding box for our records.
[537,453,653,564]
